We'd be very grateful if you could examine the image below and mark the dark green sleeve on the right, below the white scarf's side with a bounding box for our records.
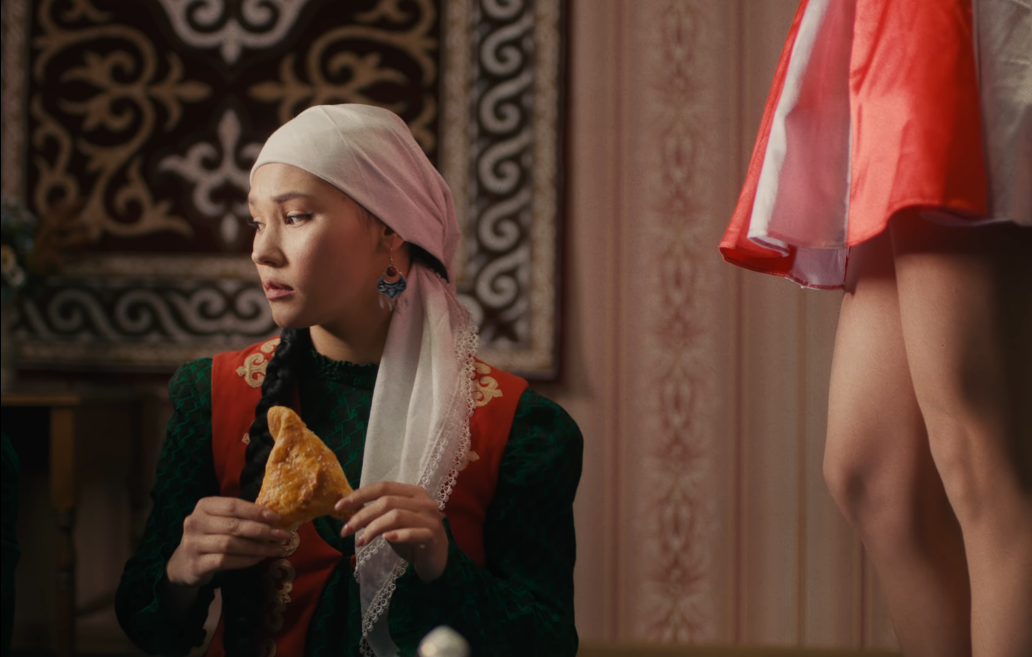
[389,390,584,657]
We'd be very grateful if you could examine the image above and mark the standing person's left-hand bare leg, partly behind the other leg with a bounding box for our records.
[825,227,971,657]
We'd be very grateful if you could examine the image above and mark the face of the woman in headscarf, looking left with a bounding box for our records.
[248,163,390,332]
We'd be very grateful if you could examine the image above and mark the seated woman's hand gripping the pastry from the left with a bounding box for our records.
[166,497,290,588]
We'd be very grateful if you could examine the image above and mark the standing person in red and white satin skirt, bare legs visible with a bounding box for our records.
[720,0,1032,657]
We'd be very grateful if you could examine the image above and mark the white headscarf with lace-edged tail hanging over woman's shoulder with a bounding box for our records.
[251,105,477,657]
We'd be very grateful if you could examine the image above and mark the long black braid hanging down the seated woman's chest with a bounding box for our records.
[222,329,312,657]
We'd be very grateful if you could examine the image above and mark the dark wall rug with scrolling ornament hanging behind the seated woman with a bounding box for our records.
[2,0,563,379]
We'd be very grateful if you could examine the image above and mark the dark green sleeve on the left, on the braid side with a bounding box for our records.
[115,358,219,655]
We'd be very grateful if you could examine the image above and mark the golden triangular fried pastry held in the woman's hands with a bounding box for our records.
[255,406,352,529]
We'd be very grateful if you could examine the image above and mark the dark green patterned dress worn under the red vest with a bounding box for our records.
[116,351,583,657]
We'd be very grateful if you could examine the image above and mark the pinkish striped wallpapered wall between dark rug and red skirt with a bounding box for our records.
[546,0,895,648]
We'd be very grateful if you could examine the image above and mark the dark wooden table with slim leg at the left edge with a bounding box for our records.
[0,389,152,657]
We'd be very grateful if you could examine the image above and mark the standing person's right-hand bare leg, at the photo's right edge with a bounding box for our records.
[891,217,1032,657]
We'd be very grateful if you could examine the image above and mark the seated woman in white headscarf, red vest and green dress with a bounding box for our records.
[117,105,582,656]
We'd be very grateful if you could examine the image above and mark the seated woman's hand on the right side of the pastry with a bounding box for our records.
[336,482,448,582]
